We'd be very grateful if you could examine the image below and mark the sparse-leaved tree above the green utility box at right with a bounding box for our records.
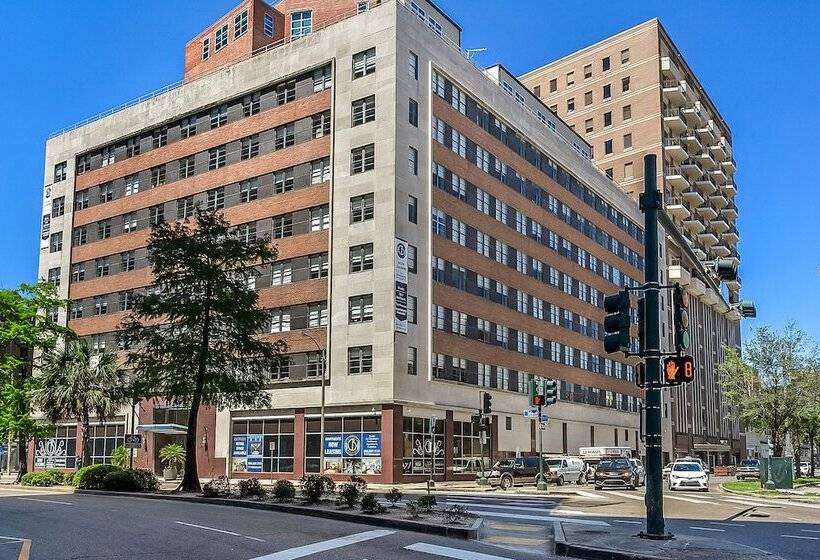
[719,323,809,456]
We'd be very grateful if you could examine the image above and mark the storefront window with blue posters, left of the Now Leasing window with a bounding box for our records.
[231,419,293,473]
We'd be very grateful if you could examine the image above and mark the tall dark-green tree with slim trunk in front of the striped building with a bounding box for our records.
[121,207,285,492]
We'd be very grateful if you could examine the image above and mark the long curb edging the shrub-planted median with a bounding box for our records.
[74,489,483,539]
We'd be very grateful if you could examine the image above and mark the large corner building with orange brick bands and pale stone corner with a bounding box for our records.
[40,0,643,481]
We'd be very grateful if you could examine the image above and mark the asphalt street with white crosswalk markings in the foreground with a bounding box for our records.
[0,486,820,560]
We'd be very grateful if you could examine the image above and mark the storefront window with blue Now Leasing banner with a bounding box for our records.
[305,416,382,475]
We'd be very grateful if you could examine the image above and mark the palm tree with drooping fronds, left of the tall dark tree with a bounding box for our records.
[37,339,123,465]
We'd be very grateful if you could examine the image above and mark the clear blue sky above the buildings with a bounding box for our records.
[0,0,820,337]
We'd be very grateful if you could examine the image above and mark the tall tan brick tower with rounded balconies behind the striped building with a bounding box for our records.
[521,19,745,465]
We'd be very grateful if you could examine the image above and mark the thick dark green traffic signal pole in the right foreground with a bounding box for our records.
[640,154,672,539]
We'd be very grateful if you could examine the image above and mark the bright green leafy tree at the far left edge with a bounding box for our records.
[0,281,72,481]
